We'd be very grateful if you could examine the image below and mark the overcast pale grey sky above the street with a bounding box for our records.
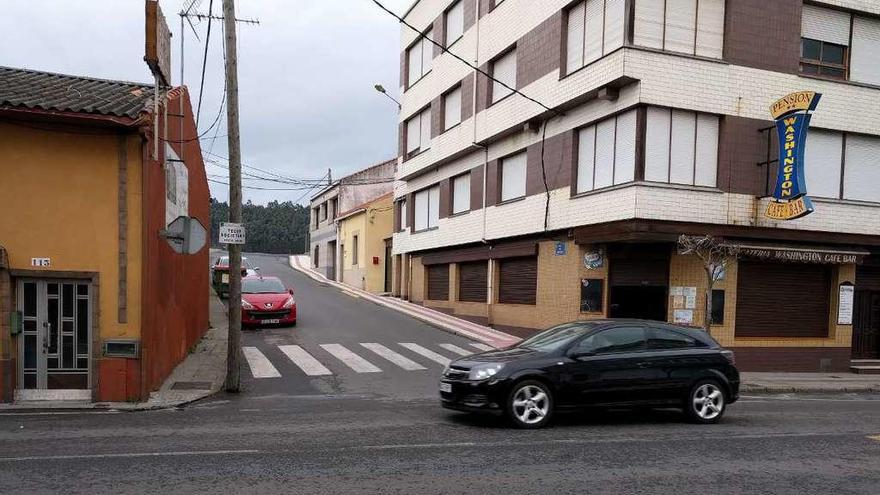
[0,0,412,203]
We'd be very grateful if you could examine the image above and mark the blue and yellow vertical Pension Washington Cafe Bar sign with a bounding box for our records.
[765,91,822,220]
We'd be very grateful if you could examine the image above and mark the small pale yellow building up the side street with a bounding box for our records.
[338,193,394,294]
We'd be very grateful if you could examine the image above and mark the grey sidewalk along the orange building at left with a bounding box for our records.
[0,289,229,411]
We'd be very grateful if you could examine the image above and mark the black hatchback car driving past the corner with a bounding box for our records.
[440,320,739,428]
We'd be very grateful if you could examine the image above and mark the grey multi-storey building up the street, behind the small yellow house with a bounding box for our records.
[309,160,397,281]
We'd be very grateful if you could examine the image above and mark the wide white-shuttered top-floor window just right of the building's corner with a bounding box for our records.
[633,0,725,58]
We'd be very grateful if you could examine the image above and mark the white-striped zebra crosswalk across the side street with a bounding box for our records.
[242,342,493,379]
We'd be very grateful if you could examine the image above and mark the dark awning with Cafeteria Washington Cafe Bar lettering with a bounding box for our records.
[728,241,871,265]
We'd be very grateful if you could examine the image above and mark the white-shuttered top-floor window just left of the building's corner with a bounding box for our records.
[565,0,626,74]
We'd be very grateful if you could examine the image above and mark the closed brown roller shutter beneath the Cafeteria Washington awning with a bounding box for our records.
[736,261,831,337]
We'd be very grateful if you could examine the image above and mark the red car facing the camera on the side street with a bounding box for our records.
[241,276,296,326]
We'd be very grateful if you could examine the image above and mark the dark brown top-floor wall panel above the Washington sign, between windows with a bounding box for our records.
[724,0,803,74]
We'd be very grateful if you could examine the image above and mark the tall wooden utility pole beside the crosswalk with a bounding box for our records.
[223,0,242,392]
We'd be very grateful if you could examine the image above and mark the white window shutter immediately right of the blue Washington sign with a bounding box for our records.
[804,129,843,198]
